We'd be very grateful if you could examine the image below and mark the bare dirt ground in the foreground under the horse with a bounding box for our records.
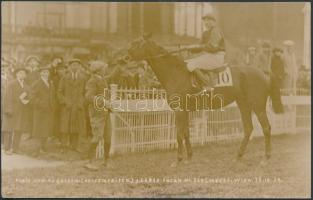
[2,133,311,198]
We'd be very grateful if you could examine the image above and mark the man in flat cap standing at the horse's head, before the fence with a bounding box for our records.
[85,61,111,170]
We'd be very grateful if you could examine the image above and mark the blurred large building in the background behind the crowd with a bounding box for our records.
[1,2,310,69]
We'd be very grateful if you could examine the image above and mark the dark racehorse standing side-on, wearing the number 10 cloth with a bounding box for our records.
[124,36,283,166]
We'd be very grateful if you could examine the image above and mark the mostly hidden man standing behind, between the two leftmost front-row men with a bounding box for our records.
[25,56,40,139]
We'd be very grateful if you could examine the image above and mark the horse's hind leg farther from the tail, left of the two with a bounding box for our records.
[237,105,253,159]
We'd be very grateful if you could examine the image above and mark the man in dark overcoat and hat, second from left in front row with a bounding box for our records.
[31,67,55,155]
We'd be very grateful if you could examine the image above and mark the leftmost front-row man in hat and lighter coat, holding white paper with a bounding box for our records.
[2,67,30,154]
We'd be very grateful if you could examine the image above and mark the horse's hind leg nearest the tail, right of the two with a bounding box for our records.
[255,109,271,159]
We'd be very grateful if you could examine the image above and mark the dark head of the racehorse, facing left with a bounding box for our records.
[128,34,164,61]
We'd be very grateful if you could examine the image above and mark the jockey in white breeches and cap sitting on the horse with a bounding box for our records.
[186,14,225,84]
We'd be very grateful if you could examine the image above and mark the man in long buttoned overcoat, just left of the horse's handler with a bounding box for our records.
[57,59,86,152]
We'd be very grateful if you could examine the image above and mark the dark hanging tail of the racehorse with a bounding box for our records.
[270,74,284,114]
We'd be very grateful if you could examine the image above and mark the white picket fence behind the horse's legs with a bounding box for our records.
[98,85,311,157]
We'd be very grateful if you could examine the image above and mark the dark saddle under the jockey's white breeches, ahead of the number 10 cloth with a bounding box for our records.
[191,64,227,89]
